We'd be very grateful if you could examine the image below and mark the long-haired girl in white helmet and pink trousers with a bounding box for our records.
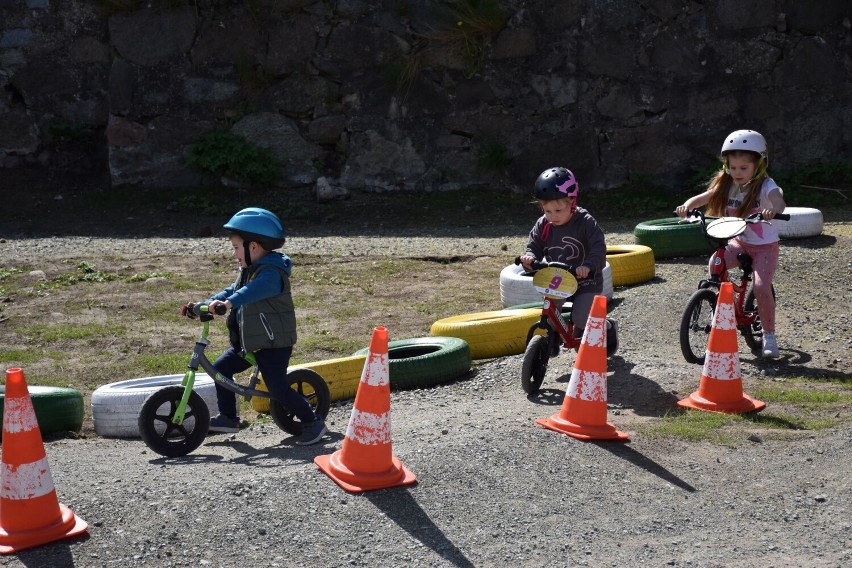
[676,130,787,358]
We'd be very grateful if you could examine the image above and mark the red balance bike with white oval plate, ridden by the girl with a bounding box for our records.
[680,209,790,365]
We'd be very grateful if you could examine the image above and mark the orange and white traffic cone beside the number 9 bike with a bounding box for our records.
[536,296,628,441]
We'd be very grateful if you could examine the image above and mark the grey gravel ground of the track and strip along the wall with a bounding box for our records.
[0,223,852,568]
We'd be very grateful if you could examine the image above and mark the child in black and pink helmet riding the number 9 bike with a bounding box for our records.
[521,168,618,355]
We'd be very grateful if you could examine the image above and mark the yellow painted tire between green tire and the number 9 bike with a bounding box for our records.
[429,308,541,359]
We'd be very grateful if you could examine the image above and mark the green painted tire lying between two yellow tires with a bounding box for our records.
[353,335,472,390]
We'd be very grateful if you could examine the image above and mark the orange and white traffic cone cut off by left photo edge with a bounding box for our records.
[0,368,89,554]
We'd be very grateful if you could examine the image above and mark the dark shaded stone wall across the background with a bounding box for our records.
[0,0,852,194]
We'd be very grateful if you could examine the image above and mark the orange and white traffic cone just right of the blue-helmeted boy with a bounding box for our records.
[314,327,417,493]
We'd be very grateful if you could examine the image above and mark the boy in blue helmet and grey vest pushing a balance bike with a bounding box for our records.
[188,207,327,446]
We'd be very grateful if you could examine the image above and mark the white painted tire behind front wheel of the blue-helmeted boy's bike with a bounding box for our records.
[92,373,219,438]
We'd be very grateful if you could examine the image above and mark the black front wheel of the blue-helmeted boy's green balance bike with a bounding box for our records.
[139,385,210,458]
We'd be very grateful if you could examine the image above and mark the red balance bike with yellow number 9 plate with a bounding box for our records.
[515,257,618,395]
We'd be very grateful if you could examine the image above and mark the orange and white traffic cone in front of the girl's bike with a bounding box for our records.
[677,282,766,414]
